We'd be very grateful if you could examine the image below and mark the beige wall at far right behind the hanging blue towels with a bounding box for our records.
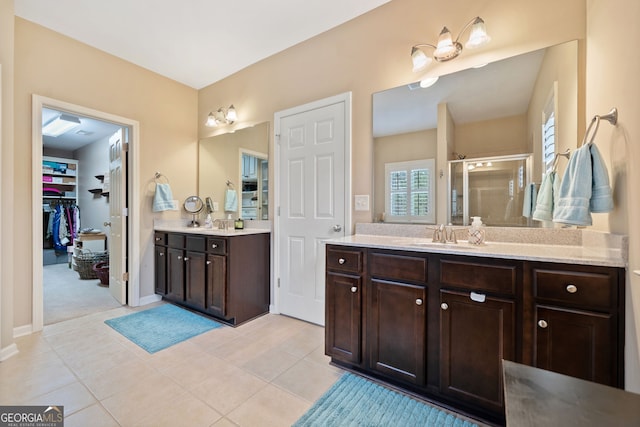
[586,0,640,393]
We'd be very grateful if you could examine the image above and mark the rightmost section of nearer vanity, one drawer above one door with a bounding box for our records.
[530,263,624,387]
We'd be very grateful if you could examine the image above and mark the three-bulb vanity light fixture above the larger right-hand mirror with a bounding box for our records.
[411,16,491,72]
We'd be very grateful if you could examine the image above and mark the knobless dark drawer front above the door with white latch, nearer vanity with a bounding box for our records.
[440,259,518,295]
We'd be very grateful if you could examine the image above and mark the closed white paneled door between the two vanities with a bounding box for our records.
[275,94,350,325]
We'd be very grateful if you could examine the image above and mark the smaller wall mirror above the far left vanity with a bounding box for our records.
[198,122,270,220]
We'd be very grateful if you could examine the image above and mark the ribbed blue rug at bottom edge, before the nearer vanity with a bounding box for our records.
[293,373,478,427]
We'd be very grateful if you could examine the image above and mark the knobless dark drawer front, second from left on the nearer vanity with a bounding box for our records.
[369,252,428,283]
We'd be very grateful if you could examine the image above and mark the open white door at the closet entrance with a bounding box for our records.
[109,128,128,304]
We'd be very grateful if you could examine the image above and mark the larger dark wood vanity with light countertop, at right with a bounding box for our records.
[325,235,625,424]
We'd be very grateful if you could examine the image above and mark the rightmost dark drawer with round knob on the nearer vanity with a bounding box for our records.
[533,268,616,311]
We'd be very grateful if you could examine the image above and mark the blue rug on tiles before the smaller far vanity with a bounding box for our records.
[104,304,222,353]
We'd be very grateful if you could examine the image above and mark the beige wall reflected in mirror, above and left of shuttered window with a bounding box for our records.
[373,129,438,221]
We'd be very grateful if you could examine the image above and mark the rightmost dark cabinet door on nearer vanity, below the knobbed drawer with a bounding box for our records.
[534,305,618,386]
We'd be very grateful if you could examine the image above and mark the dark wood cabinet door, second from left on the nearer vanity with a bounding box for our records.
[367,279,427,385]
